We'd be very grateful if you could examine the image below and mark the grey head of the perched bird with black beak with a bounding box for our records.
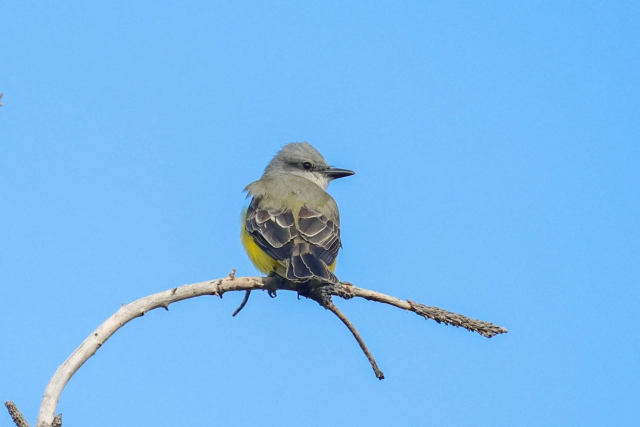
[263,142,355,189]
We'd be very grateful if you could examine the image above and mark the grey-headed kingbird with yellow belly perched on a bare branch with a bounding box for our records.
[241,142,355,283]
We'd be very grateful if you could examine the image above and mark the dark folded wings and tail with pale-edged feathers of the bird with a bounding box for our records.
[245,201,341,282]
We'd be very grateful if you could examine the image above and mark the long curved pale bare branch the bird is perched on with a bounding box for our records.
[21,271,507,427]
